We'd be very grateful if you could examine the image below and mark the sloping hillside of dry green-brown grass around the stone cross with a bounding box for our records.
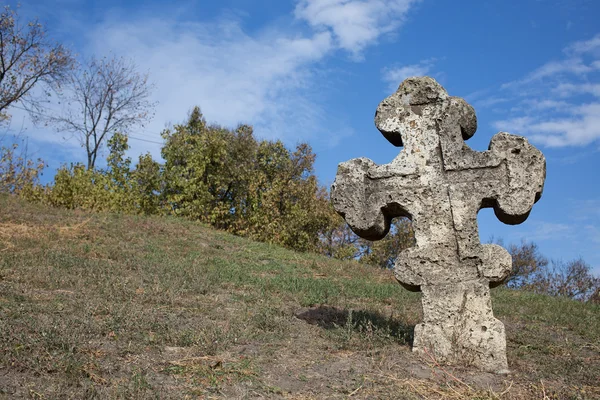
[0,197,600,399]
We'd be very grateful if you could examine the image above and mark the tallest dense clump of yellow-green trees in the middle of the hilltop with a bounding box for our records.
[162,107,330,251]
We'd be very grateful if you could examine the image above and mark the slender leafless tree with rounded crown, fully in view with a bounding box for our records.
[49,57,154,169]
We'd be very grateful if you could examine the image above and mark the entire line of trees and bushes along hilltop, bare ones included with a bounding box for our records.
[0,7,600,302]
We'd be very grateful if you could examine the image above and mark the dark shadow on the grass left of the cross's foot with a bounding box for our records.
[296,305,415,346]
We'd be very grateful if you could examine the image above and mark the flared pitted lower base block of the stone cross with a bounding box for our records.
[413,279,508,374]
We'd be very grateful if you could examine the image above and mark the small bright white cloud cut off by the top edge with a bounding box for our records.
[295,0,418,56]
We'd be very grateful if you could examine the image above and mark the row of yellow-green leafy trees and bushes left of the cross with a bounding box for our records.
[0,101,414,260]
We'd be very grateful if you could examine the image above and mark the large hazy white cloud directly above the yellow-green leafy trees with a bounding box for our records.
[72,19,336,159]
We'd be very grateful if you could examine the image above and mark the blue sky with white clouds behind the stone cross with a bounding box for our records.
[5,0,600,274]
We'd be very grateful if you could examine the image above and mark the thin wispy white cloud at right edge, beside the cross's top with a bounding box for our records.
[493,34,600,147]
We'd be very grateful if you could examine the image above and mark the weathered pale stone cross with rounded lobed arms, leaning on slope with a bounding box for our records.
[331,77,546,373]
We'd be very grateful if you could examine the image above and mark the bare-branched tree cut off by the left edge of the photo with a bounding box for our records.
[0,6,74,122]
